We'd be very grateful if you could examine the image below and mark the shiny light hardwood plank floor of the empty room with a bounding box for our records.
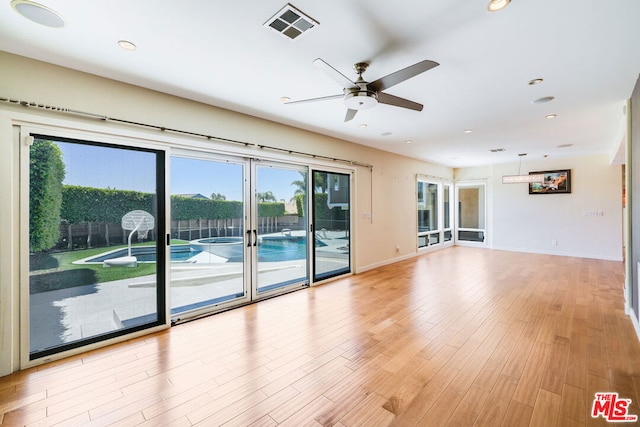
[0,247,640,427]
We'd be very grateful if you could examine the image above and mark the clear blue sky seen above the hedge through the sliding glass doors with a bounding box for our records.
[57,142,301,202]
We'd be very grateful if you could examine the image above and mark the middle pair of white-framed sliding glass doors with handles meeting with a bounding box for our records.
[170,157,309,322]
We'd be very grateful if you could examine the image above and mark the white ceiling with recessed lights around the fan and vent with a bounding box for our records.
[0,0,640,167]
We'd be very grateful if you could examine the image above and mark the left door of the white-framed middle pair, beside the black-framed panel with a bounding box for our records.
[170,154,249,321]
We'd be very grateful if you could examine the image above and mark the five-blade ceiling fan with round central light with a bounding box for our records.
[286,58,440,122]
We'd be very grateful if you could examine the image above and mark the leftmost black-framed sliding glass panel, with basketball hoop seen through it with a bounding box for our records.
[22,134,166,360]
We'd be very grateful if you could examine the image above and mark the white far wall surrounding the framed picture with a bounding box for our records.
[455,154,623,261]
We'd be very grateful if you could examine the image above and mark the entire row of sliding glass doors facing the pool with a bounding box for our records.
[21,135,351,363]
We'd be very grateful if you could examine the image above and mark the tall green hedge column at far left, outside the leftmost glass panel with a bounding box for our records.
[29,139,65,252]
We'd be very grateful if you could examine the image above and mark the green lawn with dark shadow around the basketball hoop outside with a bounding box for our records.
[29,240,186,294]
